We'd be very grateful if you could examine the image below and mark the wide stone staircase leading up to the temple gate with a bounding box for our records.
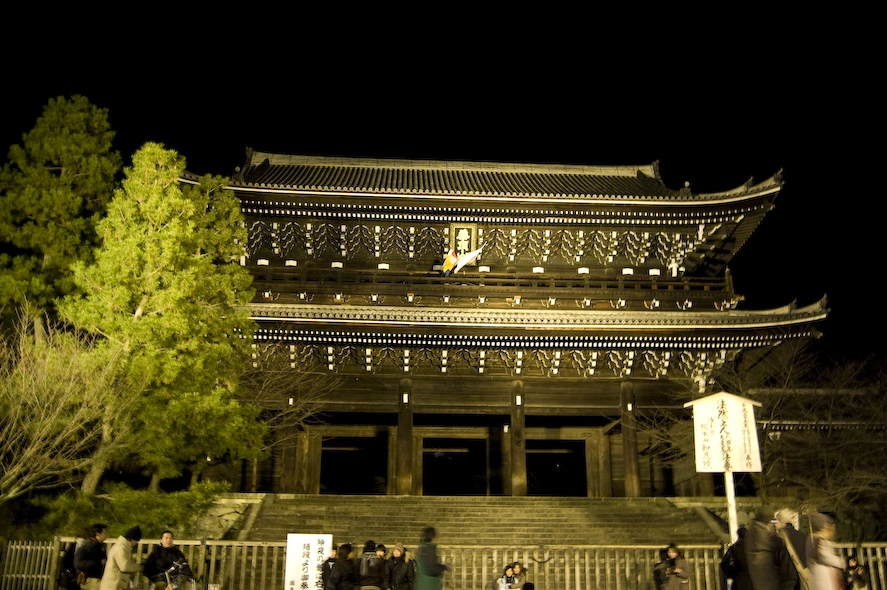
[239,494,721,551]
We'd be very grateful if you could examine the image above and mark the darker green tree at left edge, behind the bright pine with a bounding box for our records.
[0,96,122,322]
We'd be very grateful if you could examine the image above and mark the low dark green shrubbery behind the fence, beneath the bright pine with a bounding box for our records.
[33,482,228,539]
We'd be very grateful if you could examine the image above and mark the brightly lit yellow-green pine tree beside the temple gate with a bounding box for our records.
[59,143,264,487]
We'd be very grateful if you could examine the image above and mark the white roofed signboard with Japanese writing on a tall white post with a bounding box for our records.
[684,391,761,542]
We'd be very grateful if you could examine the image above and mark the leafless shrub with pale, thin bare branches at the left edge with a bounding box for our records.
[0,318,134,504]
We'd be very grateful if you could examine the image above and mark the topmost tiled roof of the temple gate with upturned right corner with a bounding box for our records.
[222,149,782,205]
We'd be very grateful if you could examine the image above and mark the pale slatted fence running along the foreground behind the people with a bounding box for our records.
[0,537,887,590]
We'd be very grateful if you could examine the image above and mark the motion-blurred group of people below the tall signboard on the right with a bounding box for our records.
[720,506,869,590]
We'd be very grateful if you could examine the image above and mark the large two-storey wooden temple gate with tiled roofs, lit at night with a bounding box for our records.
[210,149,828,497]
